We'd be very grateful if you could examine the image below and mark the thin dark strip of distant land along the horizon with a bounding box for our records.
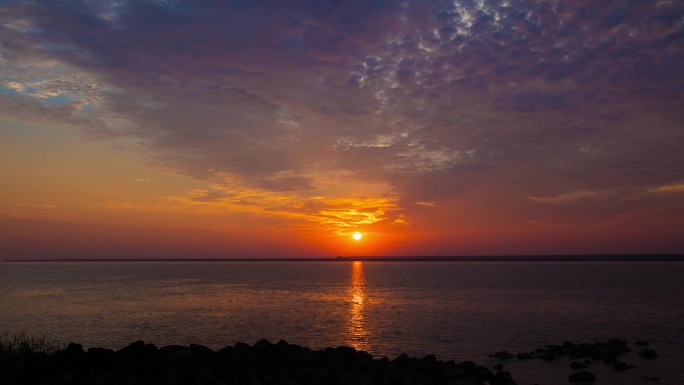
[0,254,684,262]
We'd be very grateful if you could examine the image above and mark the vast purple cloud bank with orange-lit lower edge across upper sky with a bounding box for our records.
[0,0,684,236]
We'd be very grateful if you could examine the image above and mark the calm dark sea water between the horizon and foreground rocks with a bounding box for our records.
[0,262,684,385]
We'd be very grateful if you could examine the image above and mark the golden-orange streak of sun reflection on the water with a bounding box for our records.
[347,261,371,351]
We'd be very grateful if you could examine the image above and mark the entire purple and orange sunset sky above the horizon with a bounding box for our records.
[0,0,684,259]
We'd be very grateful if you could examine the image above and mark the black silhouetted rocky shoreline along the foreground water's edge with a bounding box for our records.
[0,338,657,385]
